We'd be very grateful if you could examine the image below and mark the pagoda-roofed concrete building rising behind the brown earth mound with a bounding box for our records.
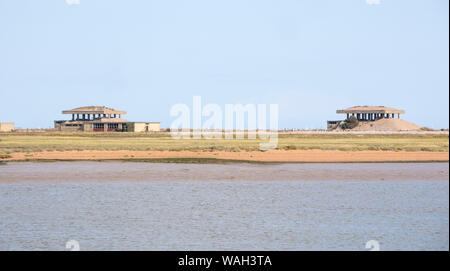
[327,105,405,130]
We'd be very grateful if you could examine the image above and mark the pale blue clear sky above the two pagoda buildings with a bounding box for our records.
[0,0,449,129]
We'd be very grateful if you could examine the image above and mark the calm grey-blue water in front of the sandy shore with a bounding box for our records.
[0,162,449,250]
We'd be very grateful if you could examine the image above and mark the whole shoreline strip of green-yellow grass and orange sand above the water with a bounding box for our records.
[0,133,449,163]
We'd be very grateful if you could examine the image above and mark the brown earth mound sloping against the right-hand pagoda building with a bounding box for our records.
[352,119,422,131]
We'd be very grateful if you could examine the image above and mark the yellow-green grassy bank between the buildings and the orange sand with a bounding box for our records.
[0,133,449,157]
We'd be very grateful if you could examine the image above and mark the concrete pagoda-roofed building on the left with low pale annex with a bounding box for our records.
[55,106,160,132]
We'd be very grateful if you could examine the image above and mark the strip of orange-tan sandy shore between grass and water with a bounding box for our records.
[0,150,449,162]
